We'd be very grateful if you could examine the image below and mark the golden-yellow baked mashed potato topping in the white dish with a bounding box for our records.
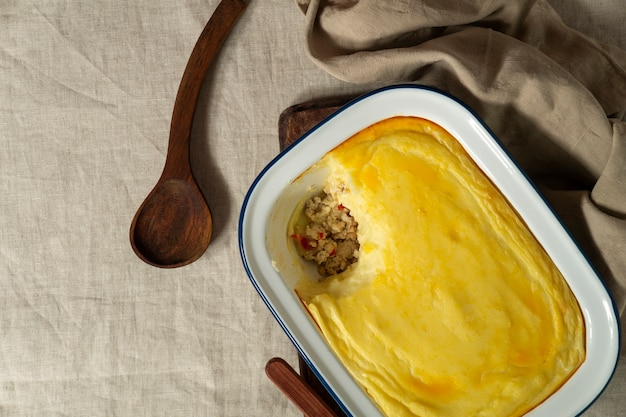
[288,117,585,417]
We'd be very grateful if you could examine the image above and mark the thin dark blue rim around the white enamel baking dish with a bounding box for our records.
[237,84,622,416]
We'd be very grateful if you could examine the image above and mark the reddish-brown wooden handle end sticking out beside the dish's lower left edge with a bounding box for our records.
[265,358,336,417]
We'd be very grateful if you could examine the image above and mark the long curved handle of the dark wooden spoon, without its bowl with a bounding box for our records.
[163,0,247,178]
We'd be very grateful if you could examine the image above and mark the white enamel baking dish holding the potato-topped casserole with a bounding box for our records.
[239,85,620,417]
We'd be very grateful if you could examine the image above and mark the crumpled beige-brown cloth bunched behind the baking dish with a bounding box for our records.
[296,0,626,344]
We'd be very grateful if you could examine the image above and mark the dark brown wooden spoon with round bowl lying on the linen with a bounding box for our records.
[130,0,246,268]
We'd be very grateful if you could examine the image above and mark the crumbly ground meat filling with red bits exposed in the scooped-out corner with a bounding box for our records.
[291,192,359,277]
